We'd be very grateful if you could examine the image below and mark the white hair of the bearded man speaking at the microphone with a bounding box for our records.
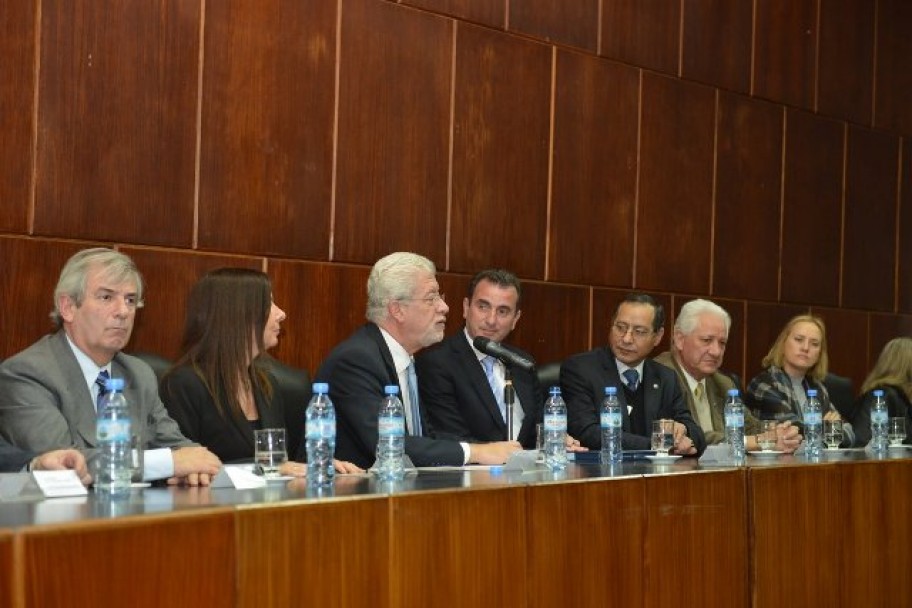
[365,251,437,323]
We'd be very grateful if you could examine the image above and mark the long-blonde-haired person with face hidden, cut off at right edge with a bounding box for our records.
[852,338,912,444]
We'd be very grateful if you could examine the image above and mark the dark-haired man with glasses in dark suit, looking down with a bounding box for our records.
[561,294,706,456]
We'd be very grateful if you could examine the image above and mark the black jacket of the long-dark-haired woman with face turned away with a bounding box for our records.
[160,365,304,462]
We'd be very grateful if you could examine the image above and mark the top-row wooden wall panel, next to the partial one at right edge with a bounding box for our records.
[817,0,877,125]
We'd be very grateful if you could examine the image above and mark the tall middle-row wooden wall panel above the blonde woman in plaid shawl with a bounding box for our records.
[781,111,845,306]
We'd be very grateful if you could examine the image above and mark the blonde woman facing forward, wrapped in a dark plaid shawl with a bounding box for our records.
[744,314,855,447]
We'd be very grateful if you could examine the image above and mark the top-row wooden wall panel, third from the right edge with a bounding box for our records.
[752,0,818,110]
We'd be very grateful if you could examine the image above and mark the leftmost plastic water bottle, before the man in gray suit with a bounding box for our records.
[95,378,133,497]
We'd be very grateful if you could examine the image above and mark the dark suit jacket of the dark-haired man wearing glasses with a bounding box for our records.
[561,347,706,454]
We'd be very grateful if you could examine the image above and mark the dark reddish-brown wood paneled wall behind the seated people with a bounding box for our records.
[0,0,912,386]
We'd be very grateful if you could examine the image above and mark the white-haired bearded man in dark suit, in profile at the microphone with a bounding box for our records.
[316,252,520,468]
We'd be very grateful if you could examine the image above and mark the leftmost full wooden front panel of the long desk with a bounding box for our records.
[21,508,237,608]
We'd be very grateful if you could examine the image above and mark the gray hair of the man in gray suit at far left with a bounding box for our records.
[51,247,143,329]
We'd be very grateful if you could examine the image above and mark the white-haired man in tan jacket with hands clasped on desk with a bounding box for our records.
[655,300,801,453]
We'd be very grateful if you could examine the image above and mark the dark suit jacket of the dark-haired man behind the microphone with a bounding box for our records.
[415,331,544,449]
